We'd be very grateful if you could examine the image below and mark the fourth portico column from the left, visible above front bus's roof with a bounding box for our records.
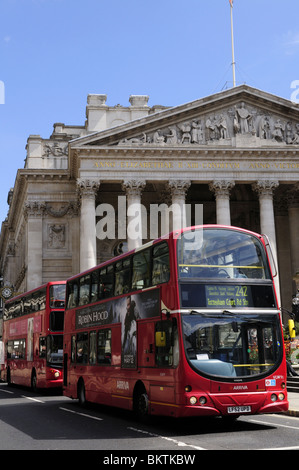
[209,180,235,225]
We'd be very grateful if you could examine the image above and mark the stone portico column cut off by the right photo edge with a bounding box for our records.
[287,183,299,289]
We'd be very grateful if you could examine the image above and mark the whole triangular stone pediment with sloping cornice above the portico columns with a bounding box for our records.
[70,85,299,150]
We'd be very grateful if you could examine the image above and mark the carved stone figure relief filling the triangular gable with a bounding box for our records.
[118,102,299,146]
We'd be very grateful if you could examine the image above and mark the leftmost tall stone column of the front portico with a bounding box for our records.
[77,178,100,272]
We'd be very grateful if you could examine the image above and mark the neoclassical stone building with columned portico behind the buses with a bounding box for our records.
[0,85,299,324]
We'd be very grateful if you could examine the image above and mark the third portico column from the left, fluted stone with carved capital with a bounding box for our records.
[167,180,191,230]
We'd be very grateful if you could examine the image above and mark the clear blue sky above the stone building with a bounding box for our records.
[0,0,299,221]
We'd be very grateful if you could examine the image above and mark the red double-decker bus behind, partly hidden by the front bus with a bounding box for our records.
[1,281,66,390]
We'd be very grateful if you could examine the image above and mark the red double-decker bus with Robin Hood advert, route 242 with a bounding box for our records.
[63,225,288,417]
